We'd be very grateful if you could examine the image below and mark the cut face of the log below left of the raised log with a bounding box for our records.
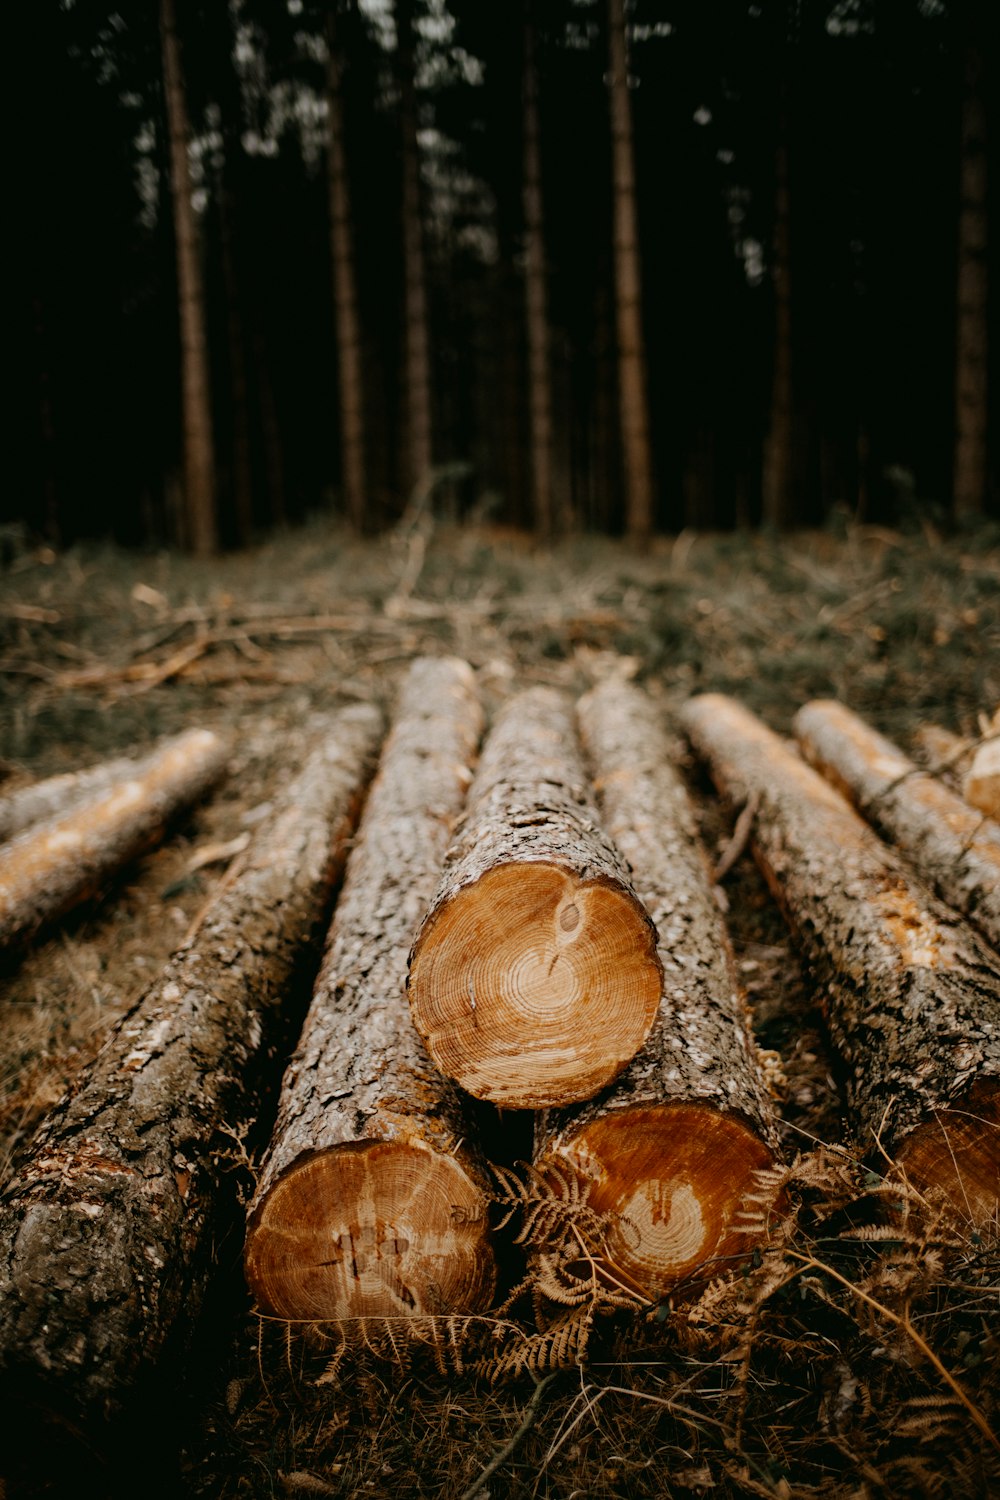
[244,1140,496,1323]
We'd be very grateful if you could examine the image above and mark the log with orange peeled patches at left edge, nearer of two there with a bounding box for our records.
[0,729,226,948]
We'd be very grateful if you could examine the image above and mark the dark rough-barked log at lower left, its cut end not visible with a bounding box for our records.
[0,707,381,1424]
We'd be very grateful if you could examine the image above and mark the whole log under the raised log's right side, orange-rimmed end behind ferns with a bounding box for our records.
[535,678,778,1299]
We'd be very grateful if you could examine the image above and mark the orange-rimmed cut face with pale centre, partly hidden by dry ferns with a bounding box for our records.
[552,1104,774,1299]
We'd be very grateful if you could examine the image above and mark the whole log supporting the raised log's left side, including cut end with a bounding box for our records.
[244,659,495,1323]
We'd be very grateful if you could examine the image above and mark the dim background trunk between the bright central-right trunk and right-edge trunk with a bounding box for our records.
[762,133,795,530]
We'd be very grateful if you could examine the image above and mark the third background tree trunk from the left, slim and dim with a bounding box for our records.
[396,0,433,500]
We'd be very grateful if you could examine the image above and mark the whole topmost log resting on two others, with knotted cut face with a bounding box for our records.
[409,687,661,1109]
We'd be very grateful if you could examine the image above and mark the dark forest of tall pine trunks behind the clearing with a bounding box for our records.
[13,0,999,554]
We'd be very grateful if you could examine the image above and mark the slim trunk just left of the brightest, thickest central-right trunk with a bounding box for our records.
[522,0,564,540]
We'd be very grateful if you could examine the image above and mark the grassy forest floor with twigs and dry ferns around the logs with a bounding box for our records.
[0,522,1000,1500]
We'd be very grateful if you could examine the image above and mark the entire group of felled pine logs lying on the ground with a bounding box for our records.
[0,659,1000,1421]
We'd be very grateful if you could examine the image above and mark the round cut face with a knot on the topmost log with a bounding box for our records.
[409,863,661,1109]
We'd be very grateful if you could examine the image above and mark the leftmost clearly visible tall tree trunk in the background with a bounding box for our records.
[160,0,219,557]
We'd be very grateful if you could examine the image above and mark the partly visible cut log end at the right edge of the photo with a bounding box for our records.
[897,1080,1000,1230]
